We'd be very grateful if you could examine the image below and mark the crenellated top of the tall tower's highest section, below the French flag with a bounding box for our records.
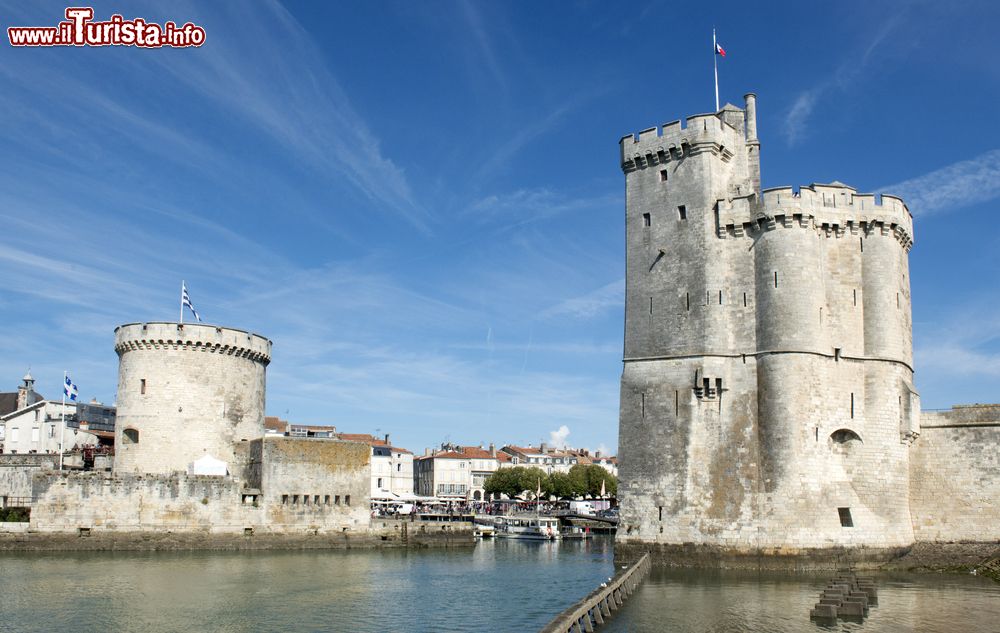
[619,105,745,173]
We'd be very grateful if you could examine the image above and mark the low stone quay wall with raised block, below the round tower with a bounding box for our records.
[31,437,370,534]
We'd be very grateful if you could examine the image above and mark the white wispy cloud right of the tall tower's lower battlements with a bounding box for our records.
[879,149,1000,215]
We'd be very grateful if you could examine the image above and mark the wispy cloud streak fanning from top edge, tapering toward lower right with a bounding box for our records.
[151,1,431,232]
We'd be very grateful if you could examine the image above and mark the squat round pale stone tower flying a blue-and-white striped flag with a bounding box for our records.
[114,323,271,473]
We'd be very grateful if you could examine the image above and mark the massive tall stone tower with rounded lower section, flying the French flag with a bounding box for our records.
[618,94,919,555]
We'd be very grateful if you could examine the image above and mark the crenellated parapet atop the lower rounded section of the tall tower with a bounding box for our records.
[717,183,913,251]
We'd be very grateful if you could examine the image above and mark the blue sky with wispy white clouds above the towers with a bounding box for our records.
[0,1,1000,451]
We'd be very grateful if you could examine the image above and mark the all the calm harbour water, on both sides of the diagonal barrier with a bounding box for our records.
[0,539,1000,633]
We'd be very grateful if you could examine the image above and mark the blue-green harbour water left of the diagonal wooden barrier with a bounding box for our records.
[0,539,612,633]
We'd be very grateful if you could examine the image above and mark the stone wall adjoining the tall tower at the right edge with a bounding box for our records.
[910,404,1000,542]
